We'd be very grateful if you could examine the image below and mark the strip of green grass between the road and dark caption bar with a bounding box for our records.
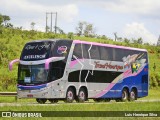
[0,102,160,111]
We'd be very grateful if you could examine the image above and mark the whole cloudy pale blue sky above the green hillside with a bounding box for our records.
[0,0,160,44]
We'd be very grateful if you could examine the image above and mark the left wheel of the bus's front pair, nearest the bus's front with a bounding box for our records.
[65,88,75,103]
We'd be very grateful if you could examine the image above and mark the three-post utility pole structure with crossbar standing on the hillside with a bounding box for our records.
[46,12,57,34]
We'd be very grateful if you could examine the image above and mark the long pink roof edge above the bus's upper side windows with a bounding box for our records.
[73,40,147,52]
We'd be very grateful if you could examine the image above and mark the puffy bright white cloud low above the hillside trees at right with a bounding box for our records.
[123,22,157,44]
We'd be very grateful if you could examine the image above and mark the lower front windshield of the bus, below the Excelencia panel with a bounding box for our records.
[18,64,48,85]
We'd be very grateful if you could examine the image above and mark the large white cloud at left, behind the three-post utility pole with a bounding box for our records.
[0,0,79,29]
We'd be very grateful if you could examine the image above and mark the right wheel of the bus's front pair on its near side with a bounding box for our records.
[78,88,87,102]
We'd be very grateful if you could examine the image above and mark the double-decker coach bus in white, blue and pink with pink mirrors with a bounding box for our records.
[9,39,149,103]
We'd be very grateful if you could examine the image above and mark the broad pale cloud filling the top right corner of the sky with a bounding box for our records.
[83,0,160,17]
